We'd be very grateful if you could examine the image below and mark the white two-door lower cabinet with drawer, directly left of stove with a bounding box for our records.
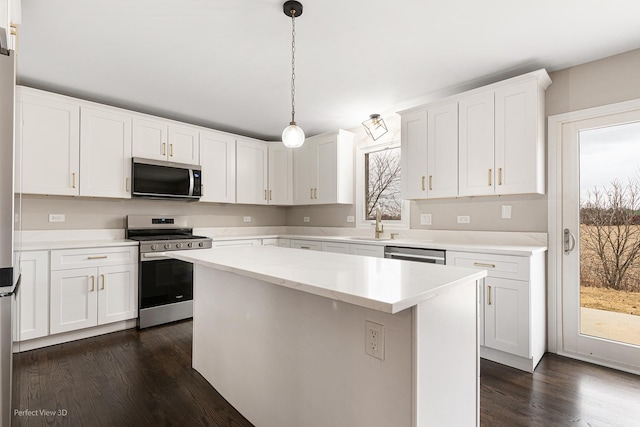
[49,246,138,334]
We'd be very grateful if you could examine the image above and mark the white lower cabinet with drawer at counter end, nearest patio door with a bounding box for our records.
[447,251,547,372]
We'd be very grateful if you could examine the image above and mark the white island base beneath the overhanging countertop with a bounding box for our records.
[185,248,484,427]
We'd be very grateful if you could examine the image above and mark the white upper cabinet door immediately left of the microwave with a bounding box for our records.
[80,107,131,199]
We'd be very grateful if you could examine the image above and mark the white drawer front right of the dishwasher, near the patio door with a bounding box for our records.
[447,251,530,281]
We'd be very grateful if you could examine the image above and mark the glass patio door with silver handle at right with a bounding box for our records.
[562,110,640,372]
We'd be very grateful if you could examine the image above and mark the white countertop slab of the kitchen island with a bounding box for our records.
[166,246,487,314]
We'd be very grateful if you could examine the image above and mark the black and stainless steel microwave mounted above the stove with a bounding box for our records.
[131,157,202,200]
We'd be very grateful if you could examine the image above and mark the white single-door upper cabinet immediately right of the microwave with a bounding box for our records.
[200,131,236,203]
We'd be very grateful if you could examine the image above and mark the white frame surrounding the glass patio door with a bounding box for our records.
[547,99,640,373]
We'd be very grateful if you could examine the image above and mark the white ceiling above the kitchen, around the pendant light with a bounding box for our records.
[13,0,640,140]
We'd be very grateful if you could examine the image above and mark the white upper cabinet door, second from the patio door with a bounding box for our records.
[459,91,495,196]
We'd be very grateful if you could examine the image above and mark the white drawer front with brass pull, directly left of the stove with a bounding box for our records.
[51,246,138,271]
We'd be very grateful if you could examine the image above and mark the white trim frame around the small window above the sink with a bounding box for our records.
[355,139,411,232]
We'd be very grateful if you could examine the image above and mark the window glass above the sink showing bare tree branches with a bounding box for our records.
[364,147,402,221]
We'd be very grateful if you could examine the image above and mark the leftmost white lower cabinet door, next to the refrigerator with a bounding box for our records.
[16,251,49,341]
